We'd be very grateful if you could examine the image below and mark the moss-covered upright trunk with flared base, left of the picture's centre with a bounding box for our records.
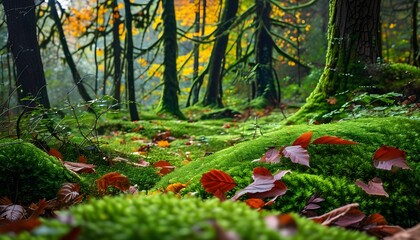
[157,0,185,119]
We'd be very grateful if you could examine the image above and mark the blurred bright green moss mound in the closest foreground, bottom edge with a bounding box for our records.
[1,194,374,240]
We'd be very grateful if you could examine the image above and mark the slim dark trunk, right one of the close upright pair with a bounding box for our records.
[124,0,140,121]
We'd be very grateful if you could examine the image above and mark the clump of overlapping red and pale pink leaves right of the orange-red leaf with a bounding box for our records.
[232,167,287,200]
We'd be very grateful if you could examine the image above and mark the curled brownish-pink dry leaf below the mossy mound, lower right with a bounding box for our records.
[310,203,365,227]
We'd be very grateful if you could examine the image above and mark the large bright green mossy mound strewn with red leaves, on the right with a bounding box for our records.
[156,117,420,227]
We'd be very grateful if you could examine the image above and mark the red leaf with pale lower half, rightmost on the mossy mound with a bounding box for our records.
[373,146,410,170]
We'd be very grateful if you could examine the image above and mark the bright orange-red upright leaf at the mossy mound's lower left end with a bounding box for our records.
[200,169,236,200]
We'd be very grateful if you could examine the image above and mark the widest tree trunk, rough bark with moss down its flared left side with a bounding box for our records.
[289,0,381,123]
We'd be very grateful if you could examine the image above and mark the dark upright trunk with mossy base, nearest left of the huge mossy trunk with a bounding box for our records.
[255,0,279,106]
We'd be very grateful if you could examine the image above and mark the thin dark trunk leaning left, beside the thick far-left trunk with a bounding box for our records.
[48,0,92,102]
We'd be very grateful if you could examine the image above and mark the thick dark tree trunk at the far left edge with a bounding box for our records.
[3,0,50,108]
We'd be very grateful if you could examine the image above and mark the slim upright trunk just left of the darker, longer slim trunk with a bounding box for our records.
[112,0,121,109]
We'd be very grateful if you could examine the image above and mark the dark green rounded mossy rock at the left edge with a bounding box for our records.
[0,140,79,204]
